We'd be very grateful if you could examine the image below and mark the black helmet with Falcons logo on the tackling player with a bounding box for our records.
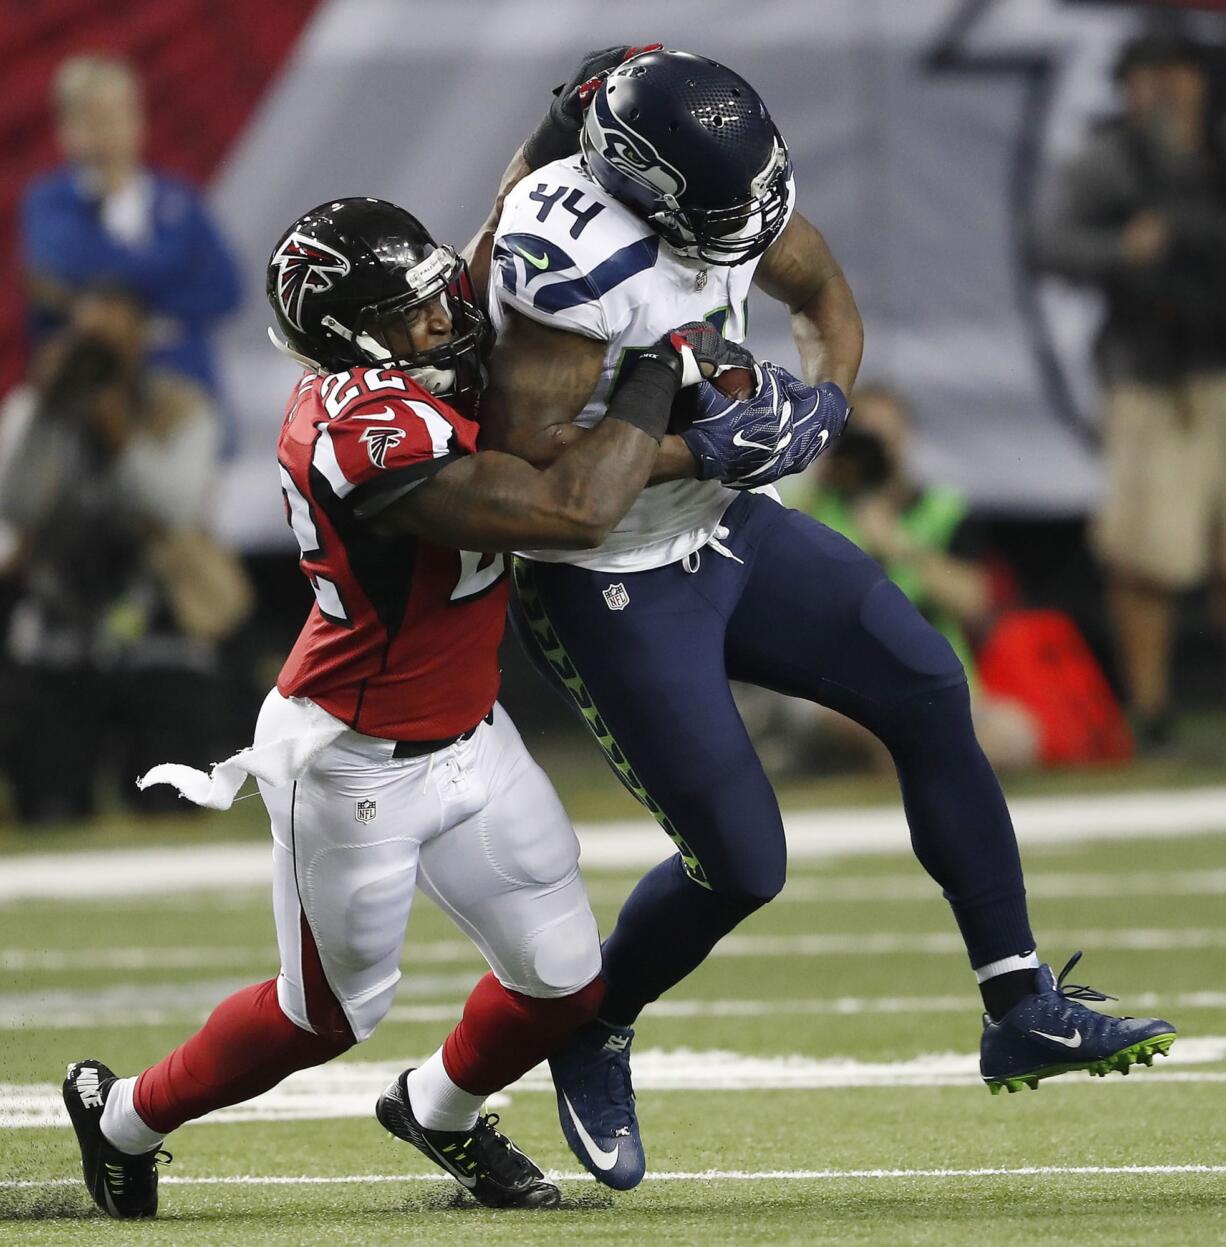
[267,198,494,398]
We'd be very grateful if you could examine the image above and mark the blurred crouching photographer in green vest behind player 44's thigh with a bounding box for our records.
[797,385,1038,771]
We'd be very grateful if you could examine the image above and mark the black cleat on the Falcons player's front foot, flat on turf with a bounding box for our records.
[374,1070,561,1208]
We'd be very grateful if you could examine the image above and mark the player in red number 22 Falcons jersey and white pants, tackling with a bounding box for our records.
[64,175,752,1217]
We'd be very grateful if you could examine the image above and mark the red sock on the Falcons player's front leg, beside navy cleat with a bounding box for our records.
[443,974,605,1095]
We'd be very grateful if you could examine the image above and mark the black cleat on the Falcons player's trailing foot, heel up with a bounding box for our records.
[64,1061,171,1221]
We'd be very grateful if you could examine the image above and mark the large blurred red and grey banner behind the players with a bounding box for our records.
[0,0,1217,550]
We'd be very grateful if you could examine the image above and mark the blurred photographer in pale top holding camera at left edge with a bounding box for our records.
[0,292,248,822]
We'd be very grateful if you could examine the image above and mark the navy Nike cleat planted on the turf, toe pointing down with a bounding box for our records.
[549,1019,647,1191]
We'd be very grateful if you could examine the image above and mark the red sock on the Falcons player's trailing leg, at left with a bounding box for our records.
[132,979,354,1135]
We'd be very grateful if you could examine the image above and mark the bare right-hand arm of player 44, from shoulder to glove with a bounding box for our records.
[753,212,864,393]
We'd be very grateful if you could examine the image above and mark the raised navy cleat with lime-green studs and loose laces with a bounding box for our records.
[979,953,1175,1095]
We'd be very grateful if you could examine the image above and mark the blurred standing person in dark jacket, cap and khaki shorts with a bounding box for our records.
[1036,34,1226,751]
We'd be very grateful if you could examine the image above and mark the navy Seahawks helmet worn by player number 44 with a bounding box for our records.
[580,49,792,264]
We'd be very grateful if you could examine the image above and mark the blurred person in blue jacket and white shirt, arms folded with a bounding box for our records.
[21,56,239,409]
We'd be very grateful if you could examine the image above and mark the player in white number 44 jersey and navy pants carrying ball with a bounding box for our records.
[481,49,1174,1188]
